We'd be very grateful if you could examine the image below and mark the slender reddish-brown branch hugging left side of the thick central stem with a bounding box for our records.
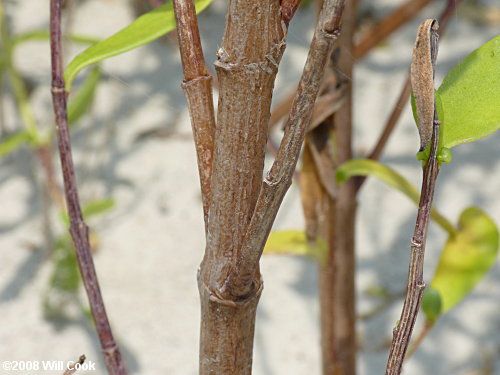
[174,0,215,230]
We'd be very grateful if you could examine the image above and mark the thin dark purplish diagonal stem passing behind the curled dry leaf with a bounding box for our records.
[356,0,460,190]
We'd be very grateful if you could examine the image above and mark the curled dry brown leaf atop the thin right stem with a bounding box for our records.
[410,19,439,151]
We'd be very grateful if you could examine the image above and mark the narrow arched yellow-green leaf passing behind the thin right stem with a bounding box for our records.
[337,159,455,235]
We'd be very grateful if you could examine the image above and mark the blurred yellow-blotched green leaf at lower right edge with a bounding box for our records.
[431,207,499,313]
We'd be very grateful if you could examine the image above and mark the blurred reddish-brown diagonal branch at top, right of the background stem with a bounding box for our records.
[354,0,432,59]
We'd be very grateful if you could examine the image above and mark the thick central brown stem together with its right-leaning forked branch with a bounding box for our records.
[193,0,343,375]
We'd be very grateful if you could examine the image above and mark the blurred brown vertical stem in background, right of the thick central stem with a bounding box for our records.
[319,0,357,375]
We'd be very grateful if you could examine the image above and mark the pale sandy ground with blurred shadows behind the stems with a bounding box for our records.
[0,0,500,375]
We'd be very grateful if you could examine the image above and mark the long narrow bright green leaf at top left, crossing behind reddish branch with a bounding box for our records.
[64,0,212,92]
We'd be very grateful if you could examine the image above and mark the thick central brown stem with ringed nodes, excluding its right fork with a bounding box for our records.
[198,0,286,375]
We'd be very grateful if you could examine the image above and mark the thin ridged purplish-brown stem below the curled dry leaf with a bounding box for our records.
[385,111,440,375]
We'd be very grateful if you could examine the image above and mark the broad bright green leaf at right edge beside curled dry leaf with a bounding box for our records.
[436,36,500,148]
